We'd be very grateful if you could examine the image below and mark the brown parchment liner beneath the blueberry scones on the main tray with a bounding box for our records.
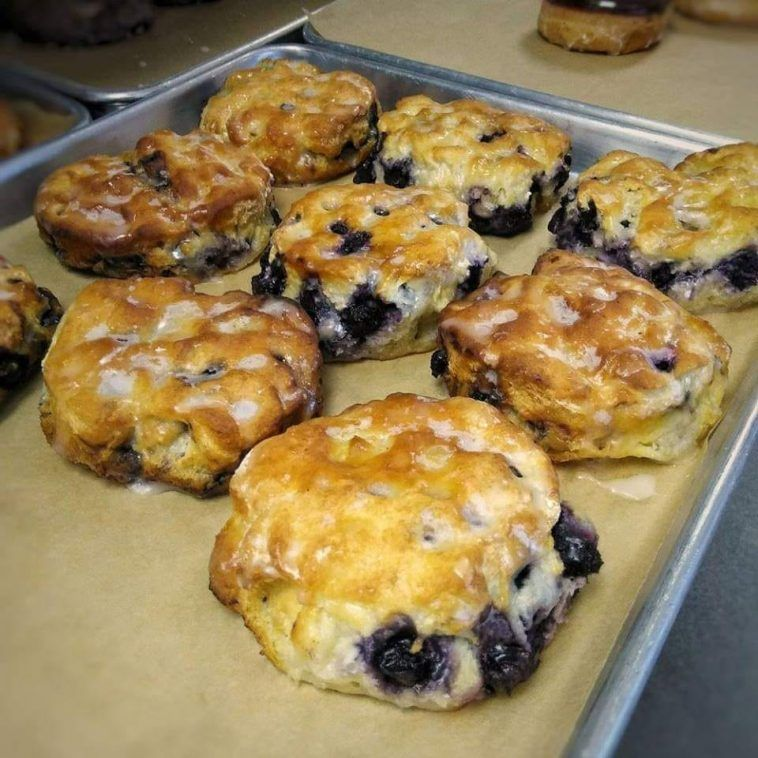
[0,175,758,758]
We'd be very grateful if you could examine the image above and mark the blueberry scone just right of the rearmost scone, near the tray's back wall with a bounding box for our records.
[354,95,571,237]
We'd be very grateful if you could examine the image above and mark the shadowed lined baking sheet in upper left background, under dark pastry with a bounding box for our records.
[0,0,328,106]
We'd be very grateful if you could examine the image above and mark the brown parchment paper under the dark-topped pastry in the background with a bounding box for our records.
[310,0,758,139]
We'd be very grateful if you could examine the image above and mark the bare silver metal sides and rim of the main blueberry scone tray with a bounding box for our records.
[0,45,758,758]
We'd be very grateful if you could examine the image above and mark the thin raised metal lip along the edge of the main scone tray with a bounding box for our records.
[5,44,758,758]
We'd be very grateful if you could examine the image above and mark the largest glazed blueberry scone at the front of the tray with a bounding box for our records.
[210,395,602,710]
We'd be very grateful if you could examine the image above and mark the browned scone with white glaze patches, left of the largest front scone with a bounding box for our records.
[40,278,321,496]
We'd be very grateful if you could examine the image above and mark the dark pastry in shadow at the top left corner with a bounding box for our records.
[0,0,155,45]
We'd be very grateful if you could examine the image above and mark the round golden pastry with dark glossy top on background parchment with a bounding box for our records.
[537,0,671,55]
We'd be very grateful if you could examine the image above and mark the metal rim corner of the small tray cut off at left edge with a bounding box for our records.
[0,66,92,172]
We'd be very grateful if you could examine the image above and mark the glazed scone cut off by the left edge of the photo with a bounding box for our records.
[0,256,63,403]
